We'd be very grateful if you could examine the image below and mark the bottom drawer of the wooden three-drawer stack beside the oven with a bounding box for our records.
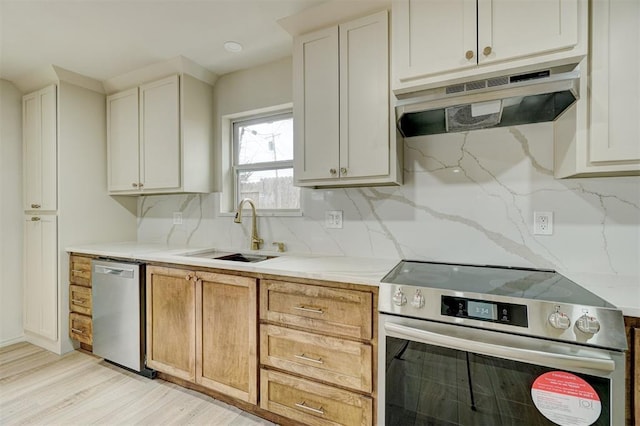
[260,369,373,426]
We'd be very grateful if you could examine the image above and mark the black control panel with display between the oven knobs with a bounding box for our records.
[440,296,529,327]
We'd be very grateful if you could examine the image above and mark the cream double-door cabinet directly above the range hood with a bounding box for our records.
[391,0,587,94]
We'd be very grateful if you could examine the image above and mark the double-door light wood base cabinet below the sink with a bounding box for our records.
[146,266,258,404]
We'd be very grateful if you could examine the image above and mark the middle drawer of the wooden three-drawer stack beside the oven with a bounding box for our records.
[260,325,372,392]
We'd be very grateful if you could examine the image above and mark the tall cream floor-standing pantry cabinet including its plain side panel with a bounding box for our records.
[18,70,136,354]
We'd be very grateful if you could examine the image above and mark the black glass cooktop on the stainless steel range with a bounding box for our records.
[382,260,615,308]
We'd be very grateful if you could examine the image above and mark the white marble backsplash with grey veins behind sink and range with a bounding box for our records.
[138,123,640,281]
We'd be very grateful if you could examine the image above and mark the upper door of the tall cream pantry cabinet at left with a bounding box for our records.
[22,85,58,210]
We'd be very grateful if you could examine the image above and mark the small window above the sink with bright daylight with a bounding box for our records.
[232,111,300,213]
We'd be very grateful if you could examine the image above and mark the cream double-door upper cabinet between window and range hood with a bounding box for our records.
[293,11,402,187]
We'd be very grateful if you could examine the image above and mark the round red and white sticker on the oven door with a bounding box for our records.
[531,371,602,426]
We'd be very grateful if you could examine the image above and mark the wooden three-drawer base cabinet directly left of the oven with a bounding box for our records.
[260,279,378,426]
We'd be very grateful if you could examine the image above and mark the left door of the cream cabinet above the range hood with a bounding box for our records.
[391,0,477,83]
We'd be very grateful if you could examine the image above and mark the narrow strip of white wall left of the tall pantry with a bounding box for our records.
[0,79,24,346]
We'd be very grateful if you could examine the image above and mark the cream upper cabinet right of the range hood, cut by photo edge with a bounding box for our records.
[555,0,640,178]
